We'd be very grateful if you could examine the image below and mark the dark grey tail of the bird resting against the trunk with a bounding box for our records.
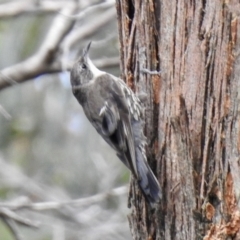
[136,148,162,207]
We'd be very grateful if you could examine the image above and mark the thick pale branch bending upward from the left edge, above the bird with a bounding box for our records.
[0,4,76,89]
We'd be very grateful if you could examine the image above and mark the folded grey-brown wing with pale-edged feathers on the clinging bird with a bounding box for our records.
[95,75,138,178]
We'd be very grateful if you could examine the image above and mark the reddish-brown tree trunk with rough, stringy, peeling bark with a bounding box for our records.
[116,0,240,240]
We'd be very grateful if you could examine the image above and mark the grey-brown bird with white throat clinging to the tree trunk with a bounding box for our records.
[70,42,162,207]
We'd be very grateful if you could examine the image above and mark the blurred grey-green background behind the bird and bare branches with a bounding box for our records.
[0,0,130,240]
